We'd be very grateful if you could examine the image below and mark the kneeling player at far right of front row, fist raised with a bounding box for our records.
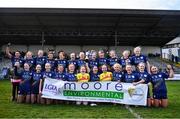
[151,65,174,107]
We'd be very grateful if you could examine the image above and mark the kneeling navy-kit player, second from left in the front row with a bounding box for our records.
[31,64,43,104]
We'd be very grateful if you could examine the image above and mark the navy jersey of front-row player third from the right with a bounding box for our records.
[123,73,139,83]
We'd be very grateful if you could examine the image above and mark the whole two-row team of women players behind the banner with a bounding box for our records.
[6,46,174,107]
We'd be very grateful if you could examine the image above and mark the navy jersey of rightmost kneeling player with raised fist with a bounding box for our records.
[151,72,169,92]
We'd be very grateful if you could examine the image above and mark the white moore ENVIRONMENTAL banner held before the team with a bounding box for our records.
[42,78,148,106]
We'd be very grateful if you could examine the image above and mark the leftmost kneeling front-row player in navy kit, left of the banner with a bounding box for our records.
[15,63,32,103]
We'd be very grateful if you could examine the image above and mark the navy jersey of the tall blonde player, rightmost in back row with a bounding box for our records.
[132,55,147,66]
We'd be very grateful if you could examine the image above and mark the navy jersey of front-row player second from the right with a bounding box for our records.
[137,71,151,84]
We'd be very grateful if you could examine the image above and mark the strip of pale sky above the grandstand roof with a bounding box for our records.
[0,0,180,10]
